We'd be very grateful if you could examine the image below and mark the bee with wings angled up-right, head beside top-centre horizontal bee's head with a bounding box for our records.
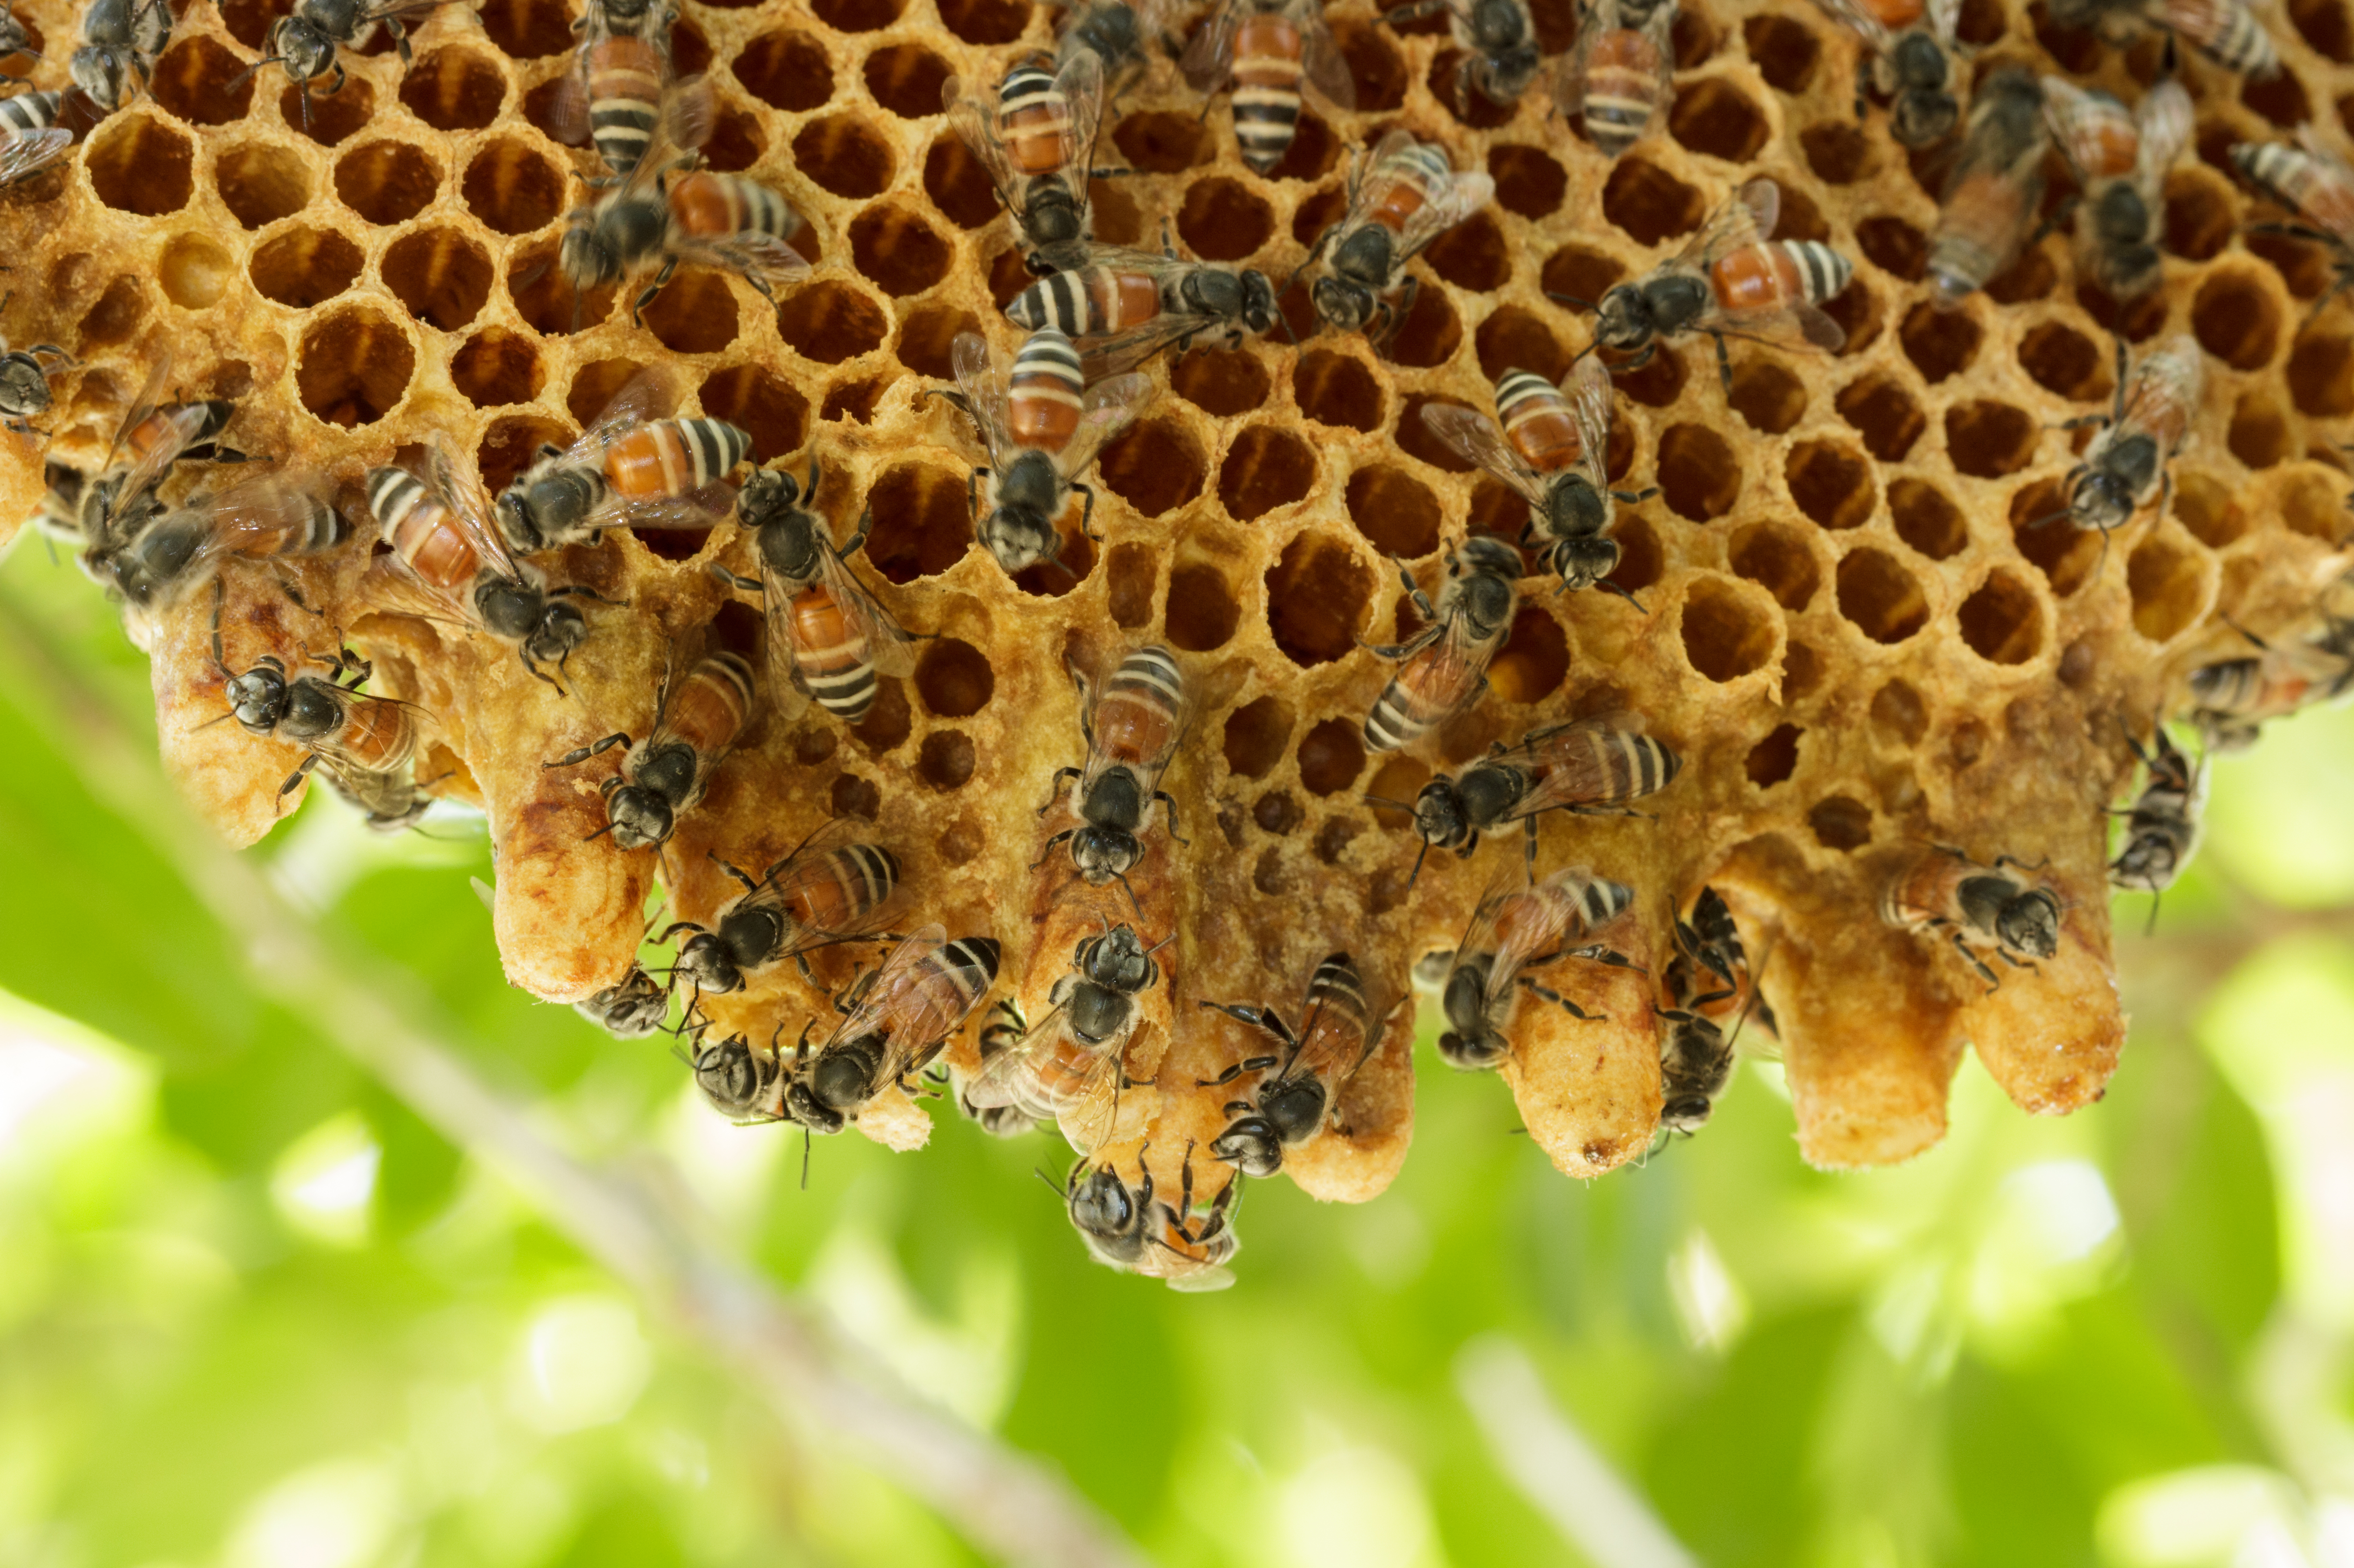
[1285,130,1495,337]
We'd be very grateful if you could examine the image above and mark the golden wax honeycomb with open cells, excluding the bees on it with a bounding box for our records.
[0,0,2354,1274]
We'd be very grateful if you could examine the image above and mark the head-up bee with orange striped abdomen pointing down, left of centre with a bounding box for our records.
[713,457,916,725]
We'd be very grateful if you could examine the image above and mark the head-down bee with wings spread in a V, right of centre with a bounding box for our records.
[1422,358,1657,610]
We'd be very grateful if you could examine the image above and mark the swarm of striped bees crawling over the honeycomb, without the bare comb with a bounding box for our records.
[0,0,2354,1290]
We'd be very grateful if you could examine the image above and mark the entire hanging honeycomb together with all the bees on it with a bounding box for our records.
[0,0,2354,1288]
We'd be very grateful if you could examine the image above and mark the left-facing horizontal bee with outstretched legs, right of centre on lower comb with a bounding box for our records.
[1365,714,1683,876]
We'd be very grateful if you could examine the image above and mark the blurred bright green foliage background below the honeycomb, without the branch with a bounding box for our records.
[0,541,2354,1568]
